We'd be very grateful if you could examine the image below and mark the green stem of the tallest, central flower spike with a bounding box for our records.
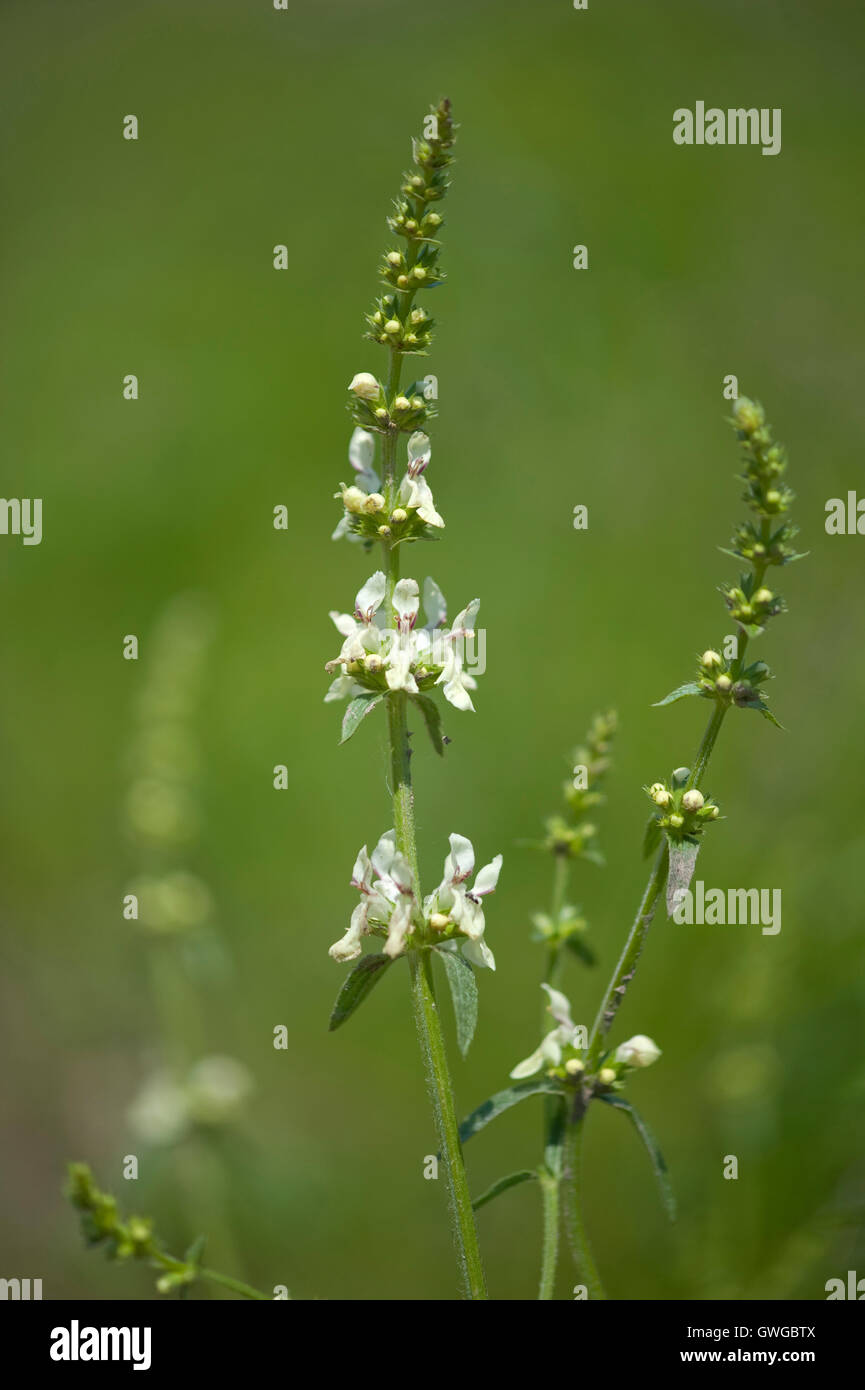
[382,394,487,1298]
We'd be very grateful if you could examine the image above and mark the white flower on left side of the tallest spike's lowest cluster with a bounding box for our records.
[328,830,414,960]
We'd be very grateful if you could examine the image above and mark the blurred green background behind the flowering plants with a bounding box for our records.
[0,0,865,1300]
